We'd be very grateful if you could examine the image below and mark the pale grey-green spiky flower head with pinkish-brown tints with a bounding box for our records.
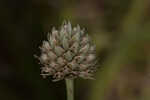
[38,22,96,81]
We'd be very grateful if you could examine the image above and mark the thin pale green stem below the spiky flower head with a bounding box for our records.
[66,79,74,100]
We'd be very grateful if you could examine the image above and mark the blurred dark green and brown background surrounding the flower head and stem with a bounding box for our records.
[0,0,150,100]
